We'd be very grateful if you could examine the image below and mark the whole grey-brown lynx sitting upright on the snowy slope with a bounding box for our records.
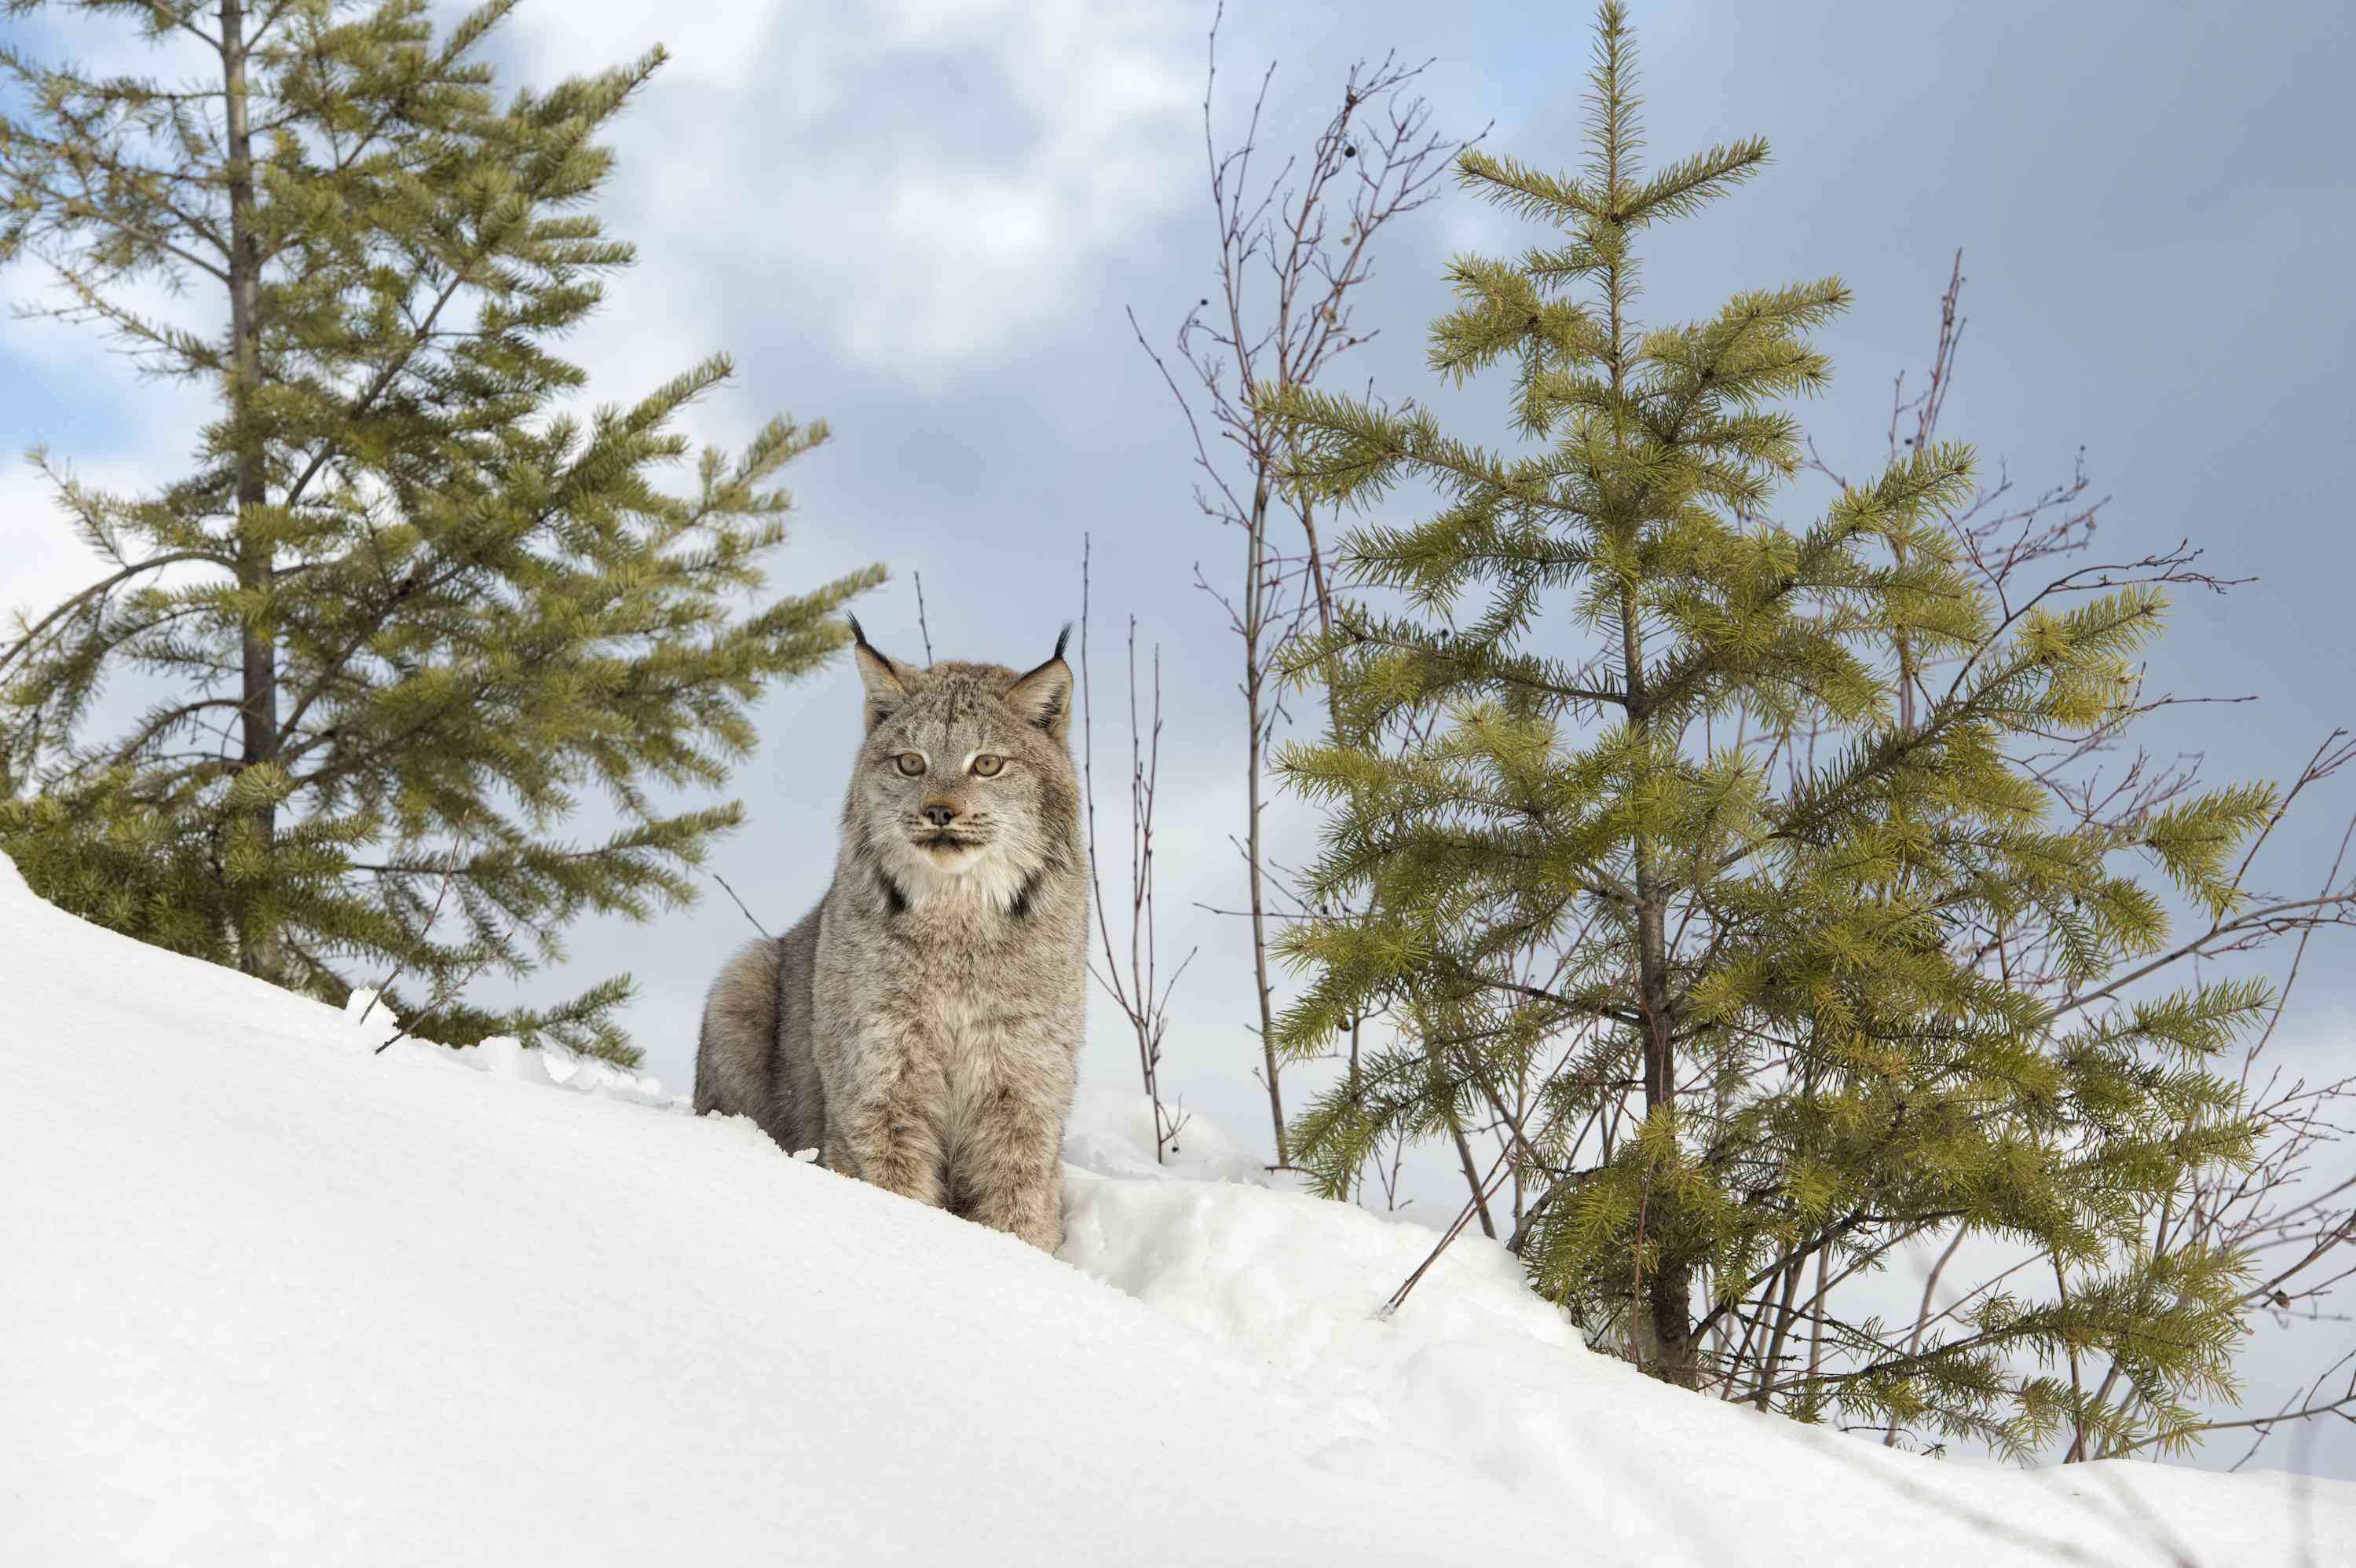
[695,622,1088,1252]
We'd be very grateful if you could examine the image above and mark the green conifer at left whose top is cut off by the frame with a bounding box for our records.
[0,0,881,1059]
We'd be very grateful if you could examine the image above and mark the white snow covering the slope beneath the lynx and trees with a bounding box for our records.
[0,859,2356,1568]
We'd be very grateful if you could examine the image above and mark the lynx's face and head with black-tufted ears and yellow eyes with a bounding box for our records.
[851,622,1079,911]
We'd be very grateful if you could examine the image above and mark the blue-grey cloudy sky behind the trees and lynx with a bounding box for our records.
[0,0,2356,1474]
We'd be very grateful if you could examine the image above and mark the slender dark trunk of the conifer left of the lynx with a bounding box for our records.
[221,0,285,981]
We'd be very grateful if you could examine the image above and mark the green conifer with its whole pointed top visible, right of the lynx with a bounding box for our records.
[1265,2,2274,1450]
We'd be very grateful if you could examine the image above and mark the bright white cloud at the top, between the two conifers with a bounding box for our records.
[509,0,1199,386]
